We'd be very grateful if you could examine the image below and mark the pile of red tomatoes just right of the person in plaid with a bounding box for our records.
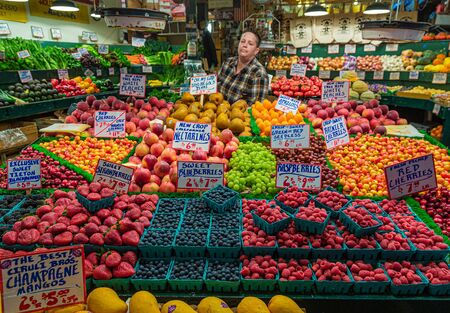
[270,76,322,98]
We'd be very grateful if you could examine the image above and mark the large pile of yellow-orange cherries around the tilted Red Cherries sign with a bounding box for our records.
[328,134,450,197]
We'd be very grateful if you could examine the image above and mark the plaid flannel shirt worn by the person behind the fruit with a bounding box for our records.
[218,57,269,105]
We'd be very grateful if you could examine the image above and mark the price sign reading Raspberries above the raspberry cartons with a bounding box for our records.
[276,162,322,190]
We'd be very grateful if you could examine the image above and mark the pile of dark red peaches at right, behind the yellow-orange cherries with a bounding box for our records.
[299,99,408,135]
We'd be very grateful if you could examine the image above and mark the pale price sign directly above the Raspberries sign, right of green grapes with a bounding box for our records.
[270,124,310,149]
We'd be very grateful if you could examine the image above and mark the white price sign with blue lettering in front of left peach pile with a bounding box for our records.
[94,111,127,138]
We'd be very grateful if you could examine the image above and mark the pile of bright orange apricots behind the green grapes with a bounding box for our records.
[252,99,304,136]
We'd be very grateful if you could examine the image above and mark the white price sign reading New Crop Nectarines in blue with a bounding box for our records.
[172,121,212,152]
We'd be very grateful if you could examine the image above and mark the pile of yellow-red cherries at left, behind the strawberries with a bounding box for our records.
[39,136,136,174]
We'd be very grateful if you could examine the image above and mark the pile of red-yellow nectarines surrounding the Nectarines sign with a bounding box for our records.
[127,127,239,193]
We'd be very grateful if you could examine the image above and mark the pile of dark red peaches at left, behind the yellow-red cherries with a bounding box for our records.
[65,95,173,138]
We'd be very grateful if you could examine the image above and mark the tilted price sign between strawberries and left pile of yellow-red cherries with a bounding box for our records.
[92,159,134,194]
